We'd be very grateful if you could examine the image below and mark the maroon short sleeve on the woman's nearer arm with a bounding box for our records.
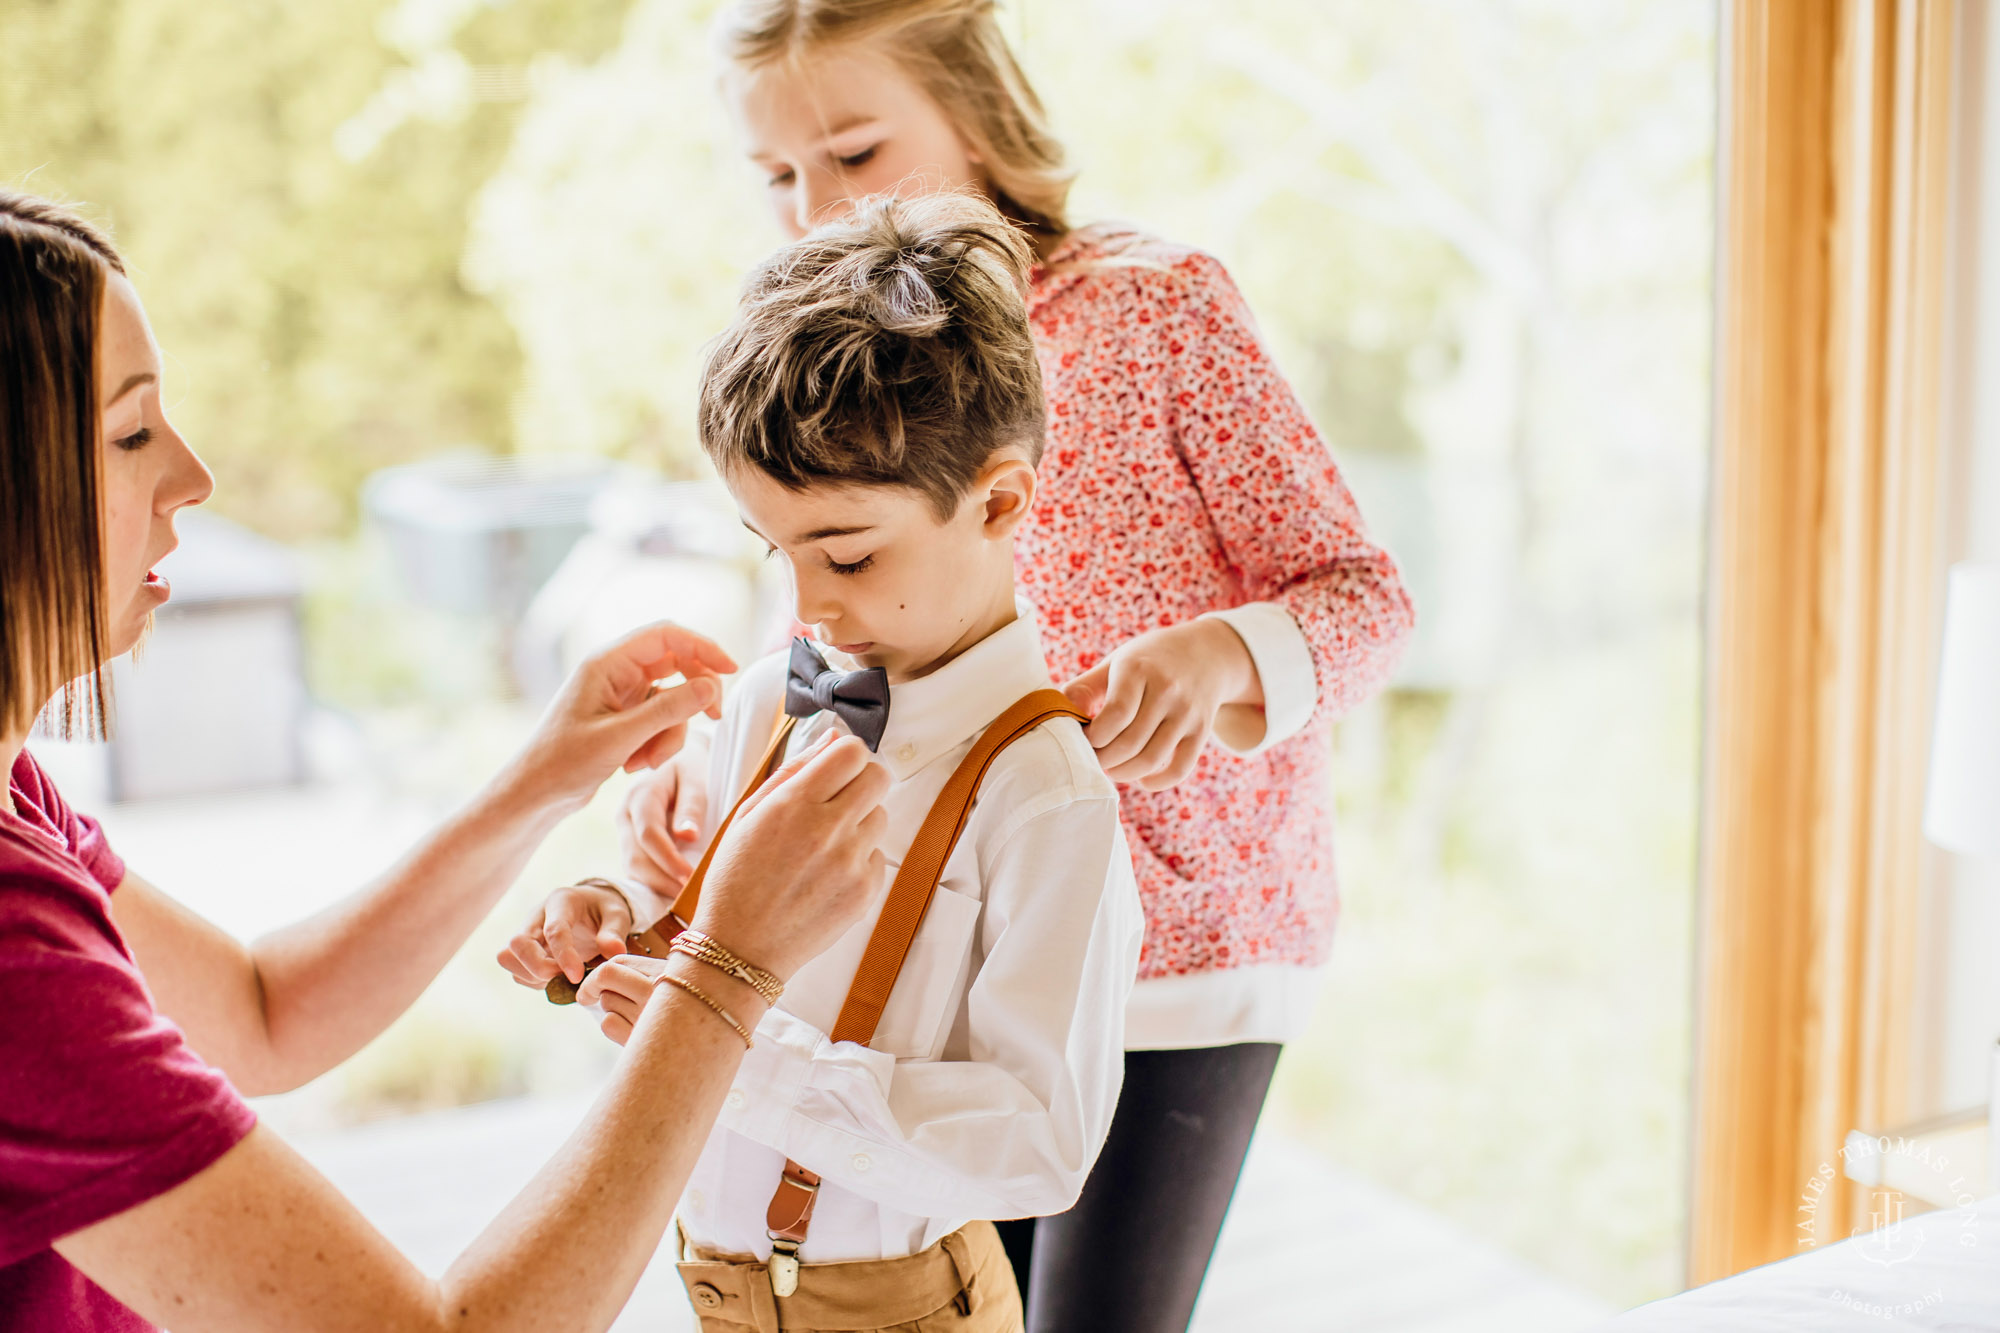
[0,872,256,1267]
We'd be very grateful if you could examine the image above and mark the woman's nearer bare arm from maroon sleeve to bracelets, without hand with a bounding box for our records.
[56,965,758,1333]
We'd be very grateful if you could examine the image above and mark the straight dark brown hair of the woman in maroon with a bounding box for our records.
[0,190,124,737]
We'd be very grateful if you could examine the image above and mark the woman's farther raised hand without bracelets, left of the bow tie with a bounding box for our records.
[502,620,736,813]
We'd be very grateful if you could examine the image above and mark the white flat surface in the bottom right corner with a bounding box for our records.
[1600,1195,2000,1333]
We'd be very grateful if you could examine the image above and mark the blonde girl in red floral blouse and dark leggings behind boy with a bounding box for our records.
[622,0,1412,1331]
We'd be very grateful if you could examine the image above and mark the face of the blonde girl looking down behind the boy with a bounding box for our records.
[722,46,992,240]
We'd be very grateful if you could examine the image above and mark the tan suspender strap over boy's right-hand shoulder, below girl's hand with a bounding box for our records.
[832,691,1090,1047]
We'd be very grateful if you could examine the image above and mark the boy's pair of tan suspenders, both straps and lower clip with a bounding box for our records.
[580,691,1090,1297]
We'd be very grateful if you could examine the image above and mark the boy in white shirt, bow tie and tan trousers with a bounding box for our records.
[512,196,1142,1333]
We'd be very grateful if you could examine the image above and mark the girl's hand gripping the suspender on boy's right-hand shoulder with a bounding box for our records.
[1062,618,1264,791]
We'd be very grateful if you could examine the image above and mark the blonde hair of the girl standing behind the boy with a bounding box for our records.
[716,0,1076,238]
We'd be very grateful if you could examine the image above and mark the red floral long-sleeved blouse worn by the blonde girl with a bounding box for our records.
[1016,228,1414,989]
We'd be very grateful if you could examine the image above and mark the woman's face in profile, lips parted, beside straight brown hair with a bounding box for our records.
[98,272,216,656]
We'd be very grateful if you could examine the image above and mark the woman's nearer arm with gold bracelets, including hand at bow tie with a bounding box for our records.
[56,741,888,1333]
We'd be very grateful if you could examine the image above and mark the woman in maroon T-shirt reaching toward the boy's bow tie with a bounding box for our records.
[0,192,886,1333]
